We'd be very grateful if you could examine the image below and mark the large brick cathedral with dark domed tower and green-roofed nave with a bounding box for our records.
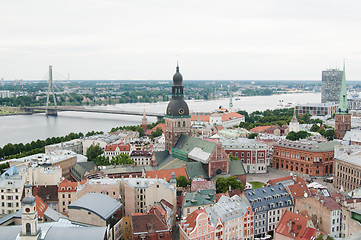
[156,64,230,178]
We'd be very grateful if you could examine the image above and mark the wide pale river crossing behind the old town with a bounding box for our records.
[0,93,321,146]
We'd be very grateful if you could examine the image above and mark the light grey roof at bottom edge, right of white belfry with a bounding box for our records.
[44,227,107,240]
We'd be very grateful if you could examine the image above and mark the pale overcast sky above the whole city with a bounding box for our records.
[0,0,361,80]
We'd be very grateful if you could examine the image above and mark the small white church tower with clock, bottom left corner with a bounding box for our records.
[20,183,40,240]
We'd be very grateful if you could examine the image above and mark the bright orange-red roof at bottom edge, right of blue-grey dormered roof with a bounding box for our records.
[275,210,316,240]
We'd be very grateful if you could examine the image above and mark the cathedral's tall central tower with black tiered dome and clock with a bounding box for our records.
[164,64,191,151]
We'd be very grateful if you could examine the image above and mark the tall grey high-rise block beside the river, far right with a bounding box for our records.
[321,69,343,103]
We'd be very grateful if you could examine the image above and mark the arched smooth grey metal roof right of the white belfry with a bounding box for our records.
[69,193,122,220]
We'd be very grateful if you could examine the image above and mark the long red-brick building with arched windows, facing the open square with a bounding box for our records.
[272,141,338,176]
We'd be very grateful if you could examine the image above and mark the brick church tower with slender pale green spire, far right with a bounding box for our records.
[335,63,351,139]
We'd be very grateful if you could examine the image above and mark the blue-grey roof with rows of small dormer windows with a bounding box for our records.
[245,184,293,212]
